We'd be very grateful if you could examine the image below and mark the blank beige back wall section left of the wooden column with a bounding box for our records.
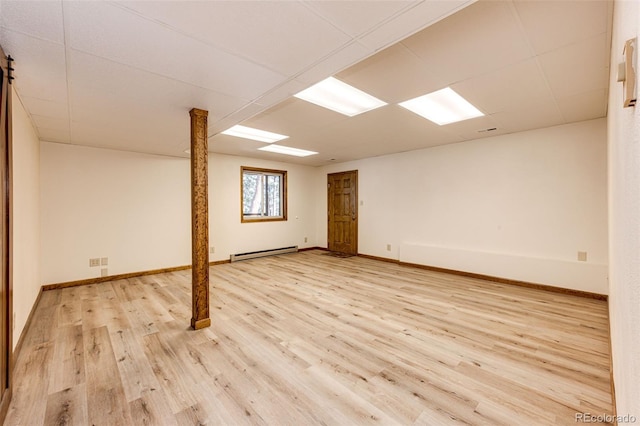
[40,142,191,284]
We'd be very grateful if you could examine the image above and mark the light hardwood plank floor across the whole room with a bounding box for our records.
[5,251,611,425]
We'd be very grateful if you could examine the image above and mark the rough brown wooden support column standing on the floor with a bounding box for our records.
[189,108,211,330]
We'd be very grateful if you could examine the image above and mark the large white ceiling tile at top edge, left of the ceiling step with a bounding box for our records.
[116,1,356,76]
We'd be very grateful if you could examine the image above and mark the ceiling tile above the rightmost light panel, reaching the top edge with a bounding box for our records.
[402,1,532,88]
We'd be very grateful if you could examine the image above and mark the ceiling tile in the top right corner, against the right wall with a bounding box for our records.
[514,0,609,54]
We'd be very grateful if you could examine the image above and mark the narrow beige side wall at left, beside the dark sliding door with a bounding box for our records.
[12,87,41,347]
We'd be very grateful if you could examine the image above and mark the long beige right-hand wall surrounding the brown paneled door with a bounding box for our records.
[316,119,608,294]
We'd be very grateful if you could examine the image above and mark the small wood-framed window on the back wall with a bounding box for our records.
[240,167,287,222]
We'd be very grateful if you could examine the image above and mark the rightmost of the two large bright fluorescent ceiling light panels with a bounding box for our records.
[399,87,484,126]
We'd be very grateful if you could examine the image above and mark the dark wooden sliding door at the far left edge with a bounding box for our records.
[0,47,12,422]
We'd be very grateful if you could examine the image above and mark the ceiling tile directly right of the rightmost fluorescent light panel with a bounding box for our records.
[451,59,553,114]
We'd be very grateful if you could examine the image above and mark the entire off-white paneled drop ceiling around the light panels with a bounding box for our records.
[0,0,612,165]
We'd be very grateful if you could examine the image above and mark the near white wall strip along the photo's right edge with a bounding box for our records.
[608,1,640,418]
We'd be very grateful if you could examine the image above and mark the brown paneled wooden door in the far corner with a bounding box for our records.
[327,170,358,254]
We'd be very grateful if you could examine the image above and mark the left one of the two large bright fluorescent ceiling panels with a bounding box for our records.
[294,77,387,117]
